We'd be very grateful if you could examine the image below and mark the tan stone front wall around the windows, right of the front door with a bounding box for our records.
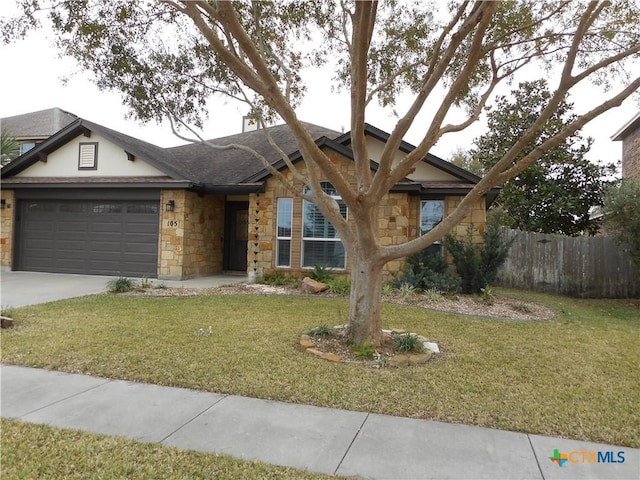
[247,152,486,279]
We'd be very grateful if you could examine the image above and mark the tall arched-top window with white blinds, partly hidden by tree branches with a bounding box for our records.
[302,182,347,268]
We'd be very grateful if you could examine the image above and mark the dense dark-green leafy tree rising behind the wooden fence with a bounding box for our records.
[470,80,615,235]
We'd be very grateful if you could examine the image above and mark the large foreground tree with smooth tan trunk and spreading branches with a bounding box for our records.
[2,0,640,345]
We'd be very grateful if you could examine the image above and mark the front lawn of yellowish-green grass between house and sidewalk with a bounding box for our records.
[2,291,640,448]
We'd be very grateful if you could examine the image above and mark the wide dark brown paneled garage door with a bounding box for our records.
[17,200,159,277]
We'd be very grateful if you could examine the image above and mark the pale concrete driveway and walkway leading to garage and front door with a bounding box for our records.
[0,272,247,308]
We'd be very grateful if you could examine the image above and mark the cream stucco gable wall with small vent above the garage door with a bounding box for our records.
[16,133,166,177]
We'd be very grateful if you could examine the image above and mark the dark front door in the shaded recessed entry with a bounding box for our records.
[224,202,249,272]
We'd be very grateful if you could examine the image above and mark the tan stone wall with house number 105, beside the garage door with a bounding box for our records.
[158,190,224,280]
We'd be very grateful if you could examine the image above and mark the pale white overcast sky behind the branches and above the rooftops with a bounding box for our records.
[0,0,640,167]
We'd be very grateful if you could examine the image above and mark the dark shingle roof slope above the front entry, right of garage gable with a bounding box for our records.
[167,122,340,185]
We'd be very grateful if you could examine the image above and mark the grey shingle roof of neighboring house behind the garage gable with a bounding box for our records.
[0,108,78,155]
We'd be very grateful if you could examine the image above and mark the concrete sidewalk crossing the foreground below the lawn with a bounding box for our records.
[0,365,640,479]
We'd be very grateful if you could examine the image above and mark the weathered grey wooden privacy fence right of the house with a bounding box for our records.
[496,228,640,298]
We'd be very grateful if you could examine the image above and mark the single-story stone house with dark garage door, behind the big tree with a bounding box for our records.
[0,112,499,279]
